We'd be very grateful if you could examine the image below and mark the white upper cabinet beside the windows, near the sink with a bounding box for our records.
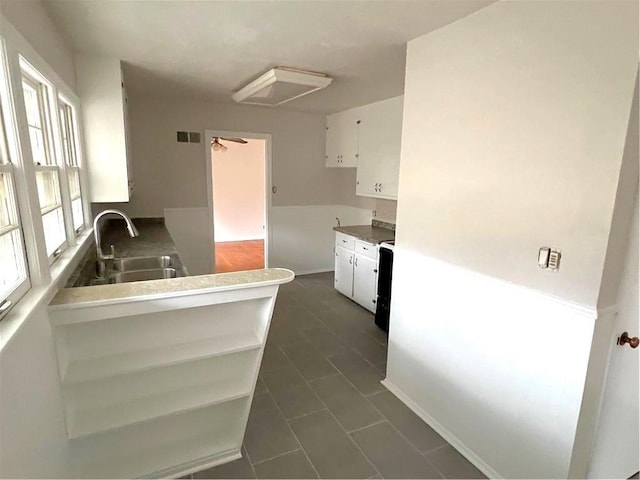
[75,54,132,202]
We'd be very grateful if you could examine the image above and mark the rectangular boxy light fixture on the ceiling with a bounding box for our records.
[233,67,333,107]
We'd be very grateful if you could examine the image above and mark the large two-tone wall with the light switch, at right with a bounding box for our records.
[387,1,638,478]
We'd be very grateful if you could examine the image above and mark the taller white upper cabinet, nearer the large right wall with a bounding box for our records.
[356,96,404,199]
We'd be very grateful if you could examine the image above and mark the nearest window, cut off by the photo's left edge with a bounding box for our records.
[0,43,30,312]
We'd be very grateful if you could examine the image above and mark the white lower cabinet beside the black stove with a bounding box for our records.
[334,233,378,312]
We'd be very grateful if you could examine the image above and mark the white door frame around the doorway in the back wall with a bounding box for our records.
[203,129,272,273]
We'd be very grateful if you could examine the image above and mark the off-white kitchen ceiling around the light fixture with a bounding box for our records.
[44,0,495,113]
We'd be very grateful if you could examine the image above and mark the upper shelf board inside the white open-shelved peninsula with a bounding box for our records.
[63,332,261,385]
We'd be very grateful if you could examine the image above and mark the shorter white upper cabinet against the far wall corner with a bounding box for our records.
[325,108,360,167]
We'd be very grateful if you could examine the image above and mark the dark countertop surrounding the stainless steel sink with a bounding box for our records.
[66,218,188,288]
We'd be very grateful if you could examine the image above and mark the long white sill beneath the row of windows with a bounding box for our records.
[0,228,93,352]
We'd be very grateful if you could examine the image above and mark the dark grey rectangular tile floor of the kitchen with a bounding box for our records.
[186,273,485,478]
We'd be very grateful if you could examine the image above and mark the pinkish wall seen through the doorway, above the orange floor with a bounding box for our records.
[211,139,266,242]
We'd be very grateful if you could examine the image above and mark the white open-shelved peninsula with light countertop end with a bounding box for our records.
[49,269,293,478]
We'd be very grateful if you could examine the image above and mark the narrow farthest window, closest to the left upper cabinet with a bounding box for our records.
[58,99,84,234]
